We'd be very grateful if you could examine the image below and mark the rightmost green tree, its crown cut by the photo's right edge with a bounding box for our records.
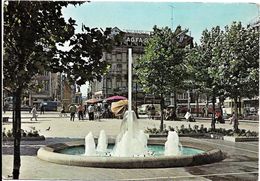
[219,22,259,130]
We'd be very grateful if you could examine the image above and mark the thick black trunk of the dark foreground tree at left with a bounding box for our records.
[13,89,22,179]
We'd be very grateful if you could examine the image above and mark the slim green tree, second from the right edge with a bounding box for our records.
[186,26,224,129]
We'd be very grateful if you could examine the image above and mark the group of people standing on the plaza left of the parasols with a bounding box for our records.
[67,104,100,121]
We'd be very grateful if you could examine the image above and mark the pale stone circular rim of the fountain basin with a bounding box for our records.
[37,138,225,168]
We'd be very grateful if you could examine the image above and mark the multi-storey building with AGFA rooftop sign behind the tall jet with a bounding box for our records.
[90,27,193,104]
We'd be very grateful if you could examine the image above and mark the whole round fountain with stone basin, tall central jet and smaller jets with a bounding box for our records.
[37,49,225,168]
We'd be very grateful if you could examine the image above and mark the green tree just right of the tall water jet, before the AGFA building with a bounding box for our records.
[135,26,188,131]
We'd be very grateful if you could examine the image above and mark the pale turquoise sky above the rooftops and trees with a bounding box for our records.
[63,1,259,95]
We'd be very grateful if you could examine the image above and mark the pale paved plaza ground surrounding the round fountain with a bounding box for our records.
[2,112,259,181]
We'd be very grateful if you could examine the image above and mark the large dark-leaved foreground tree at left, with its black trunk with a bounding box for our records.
[3,1,113,179]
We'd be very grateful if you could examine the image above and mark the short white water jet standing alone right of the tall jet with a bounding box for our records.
[164,131,181,156]
